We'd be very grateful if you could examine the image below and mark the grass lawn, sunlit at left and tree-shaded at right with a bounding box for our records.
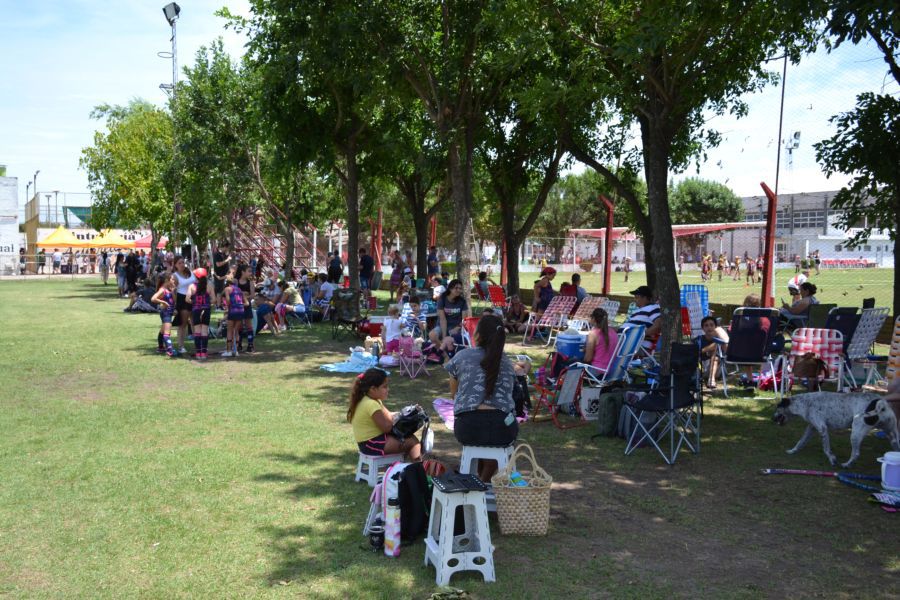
[0,278,900,598]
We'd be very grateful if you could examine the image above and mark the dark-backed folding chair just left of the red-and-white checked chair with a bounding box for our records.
[719,307,779,398]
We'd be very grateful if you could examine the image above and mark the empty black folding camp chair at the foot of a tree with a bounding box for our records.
[623,344,703,465]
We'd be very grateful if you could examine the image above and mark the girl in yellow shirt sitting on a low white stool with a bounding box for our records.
[347,369,422,461]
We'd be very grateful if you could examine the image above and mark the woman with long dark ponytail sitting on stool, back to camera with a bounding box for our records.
[444,315,519,481]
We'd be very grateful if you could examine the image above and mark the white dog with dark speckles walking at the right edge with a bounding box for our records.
[773,392,900,468]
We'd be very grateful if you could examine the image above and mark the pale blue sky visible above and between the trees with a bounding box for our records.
[0,0,898,218]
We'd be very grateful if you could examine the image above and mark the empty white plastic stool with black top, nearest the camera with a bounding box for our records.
[425,487,494,585]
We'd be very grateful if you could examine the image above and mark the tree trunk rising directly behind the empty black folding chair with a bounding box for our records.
[641,117,681,373]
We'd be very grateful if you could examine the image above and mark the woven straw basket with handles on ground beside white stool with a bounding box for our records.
[491,444,553,535]
